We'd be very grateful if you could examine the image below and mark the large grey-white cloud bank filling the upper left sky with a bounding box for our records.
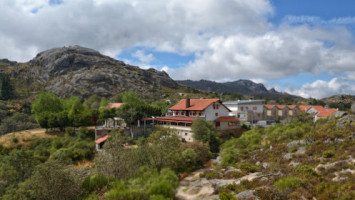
[0,0,272,61]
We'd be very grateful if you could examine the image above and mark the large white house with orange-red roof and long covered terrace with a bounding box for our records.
[143,99,239,142]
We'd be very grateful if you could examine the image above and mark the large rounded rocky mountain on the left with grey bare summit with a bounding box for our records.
[0,46,178,98]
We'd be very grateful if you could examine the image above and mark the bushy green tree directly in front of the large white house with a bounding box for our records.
[191,117,219,153]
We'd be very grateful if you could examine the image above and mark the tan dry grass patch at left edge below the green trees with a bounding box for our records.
[0,128,59,147]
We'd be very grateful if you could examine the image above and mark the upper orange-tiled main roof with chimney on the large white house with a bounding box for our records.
[169,99,230,111]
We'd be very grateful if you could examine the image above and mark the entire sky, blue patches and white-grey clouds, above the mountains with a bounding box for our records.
[0,0,355,98]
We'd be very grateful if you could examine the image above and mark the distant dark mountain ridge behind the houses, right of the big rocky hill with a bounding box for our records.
[177,79,302,100]
